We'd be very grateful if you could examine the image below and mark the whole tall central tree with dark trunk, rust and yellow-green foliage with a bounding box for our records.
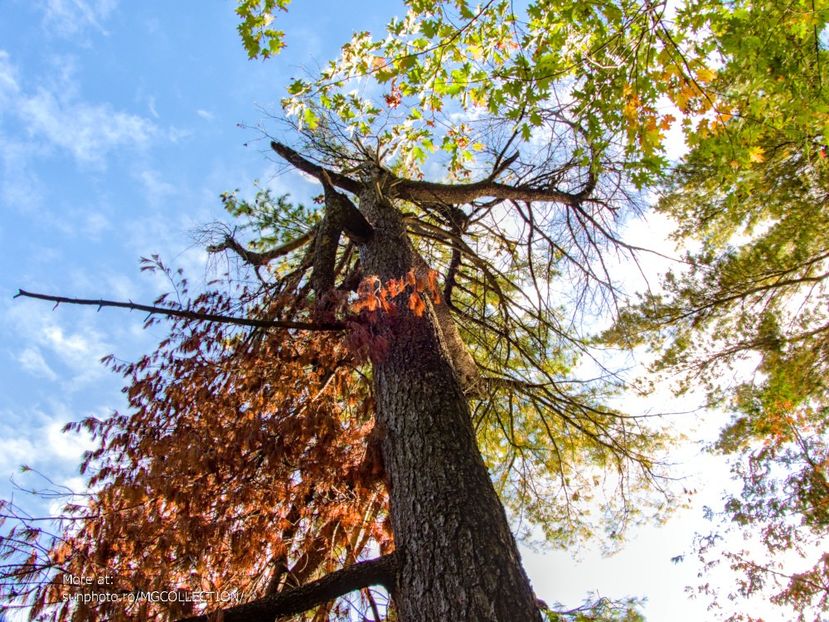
[4,0,820,621]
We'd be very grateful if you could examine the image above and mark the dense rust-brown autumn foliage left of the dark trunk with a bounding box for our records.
[2,264,394,620]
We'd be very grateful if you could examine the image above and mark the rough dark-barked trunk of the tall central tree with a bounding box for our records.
[360,188,541,622]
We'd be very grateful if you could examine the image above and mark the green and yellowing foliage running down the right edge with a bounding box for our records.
[607,1,829,620]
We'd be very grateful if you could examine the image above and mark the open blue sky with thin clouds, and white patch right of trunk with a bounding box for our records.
[0,0,788,622]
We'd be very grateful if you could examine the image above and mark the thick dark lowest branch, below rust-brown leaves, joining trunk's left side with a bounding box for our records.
[178,553,397,622]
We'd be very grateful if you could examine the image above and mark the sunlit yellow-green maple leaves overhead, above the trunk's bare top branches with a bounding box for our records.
[266,0,714,186]
